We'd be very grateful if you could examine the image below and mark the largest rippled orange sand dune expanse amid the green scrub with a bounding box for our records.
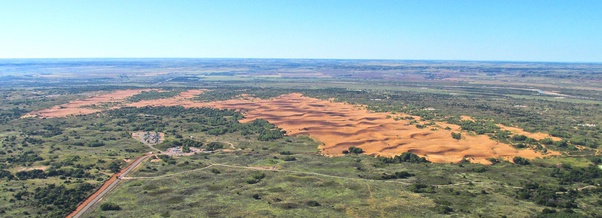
[27,90,557,164]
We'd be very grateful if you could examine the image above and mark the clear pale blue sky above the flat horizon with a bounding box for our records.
[0,0,602,62]
